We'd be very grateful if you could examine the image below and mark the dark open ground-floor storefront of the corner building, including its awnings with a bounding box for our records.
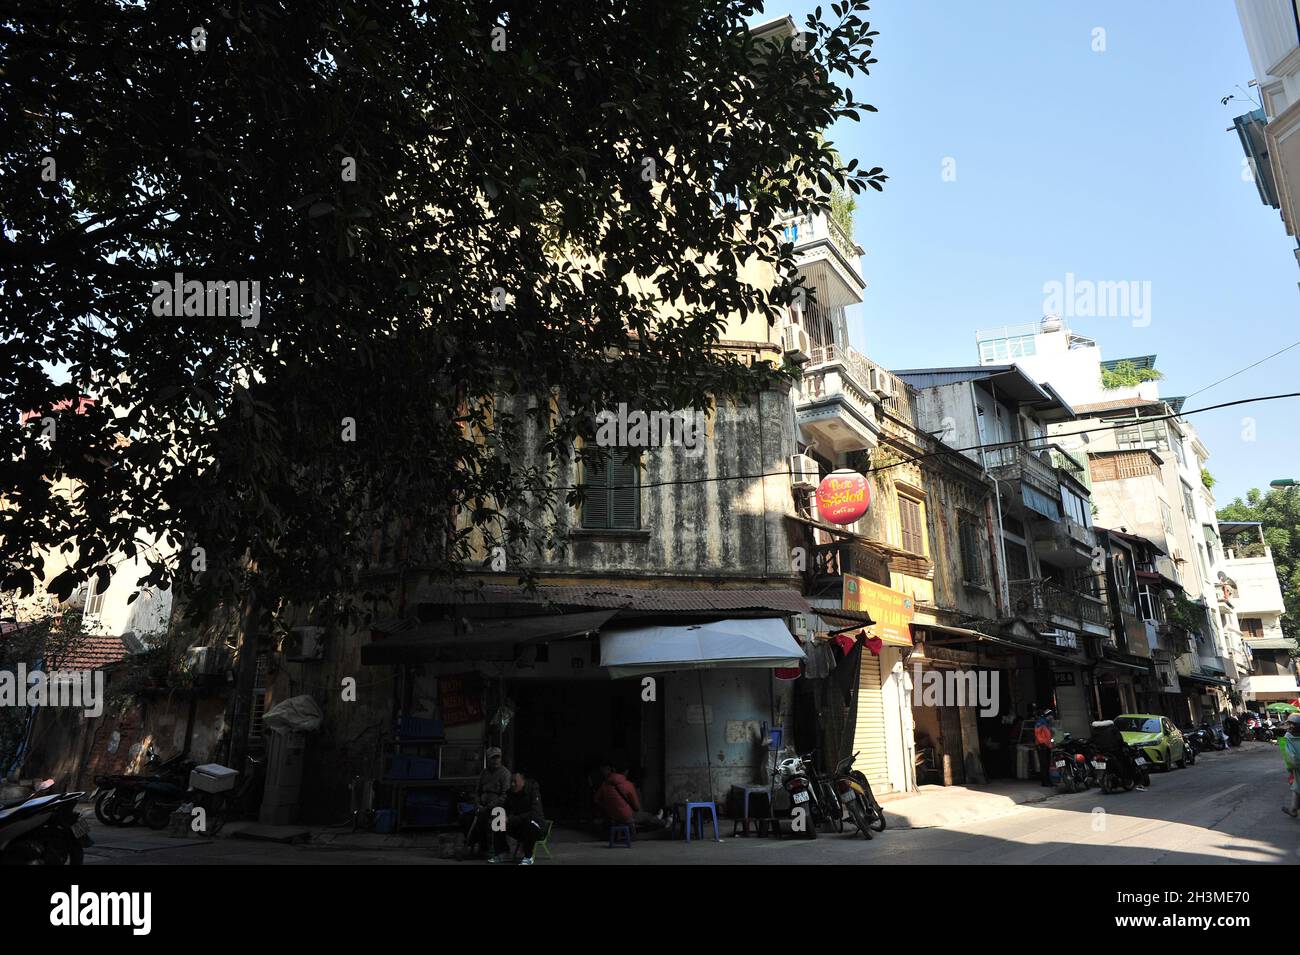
[361,591,807,825]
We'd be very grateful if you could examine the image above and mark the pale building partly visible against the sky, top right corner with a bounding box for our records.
[1235,0,1300,261]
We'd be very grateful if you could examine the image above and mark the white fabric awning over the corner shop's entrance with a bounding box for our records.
[601,618,803,678]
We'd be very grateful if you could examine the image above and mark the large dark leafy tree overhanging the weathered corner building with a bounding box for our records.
[0,0,884,625]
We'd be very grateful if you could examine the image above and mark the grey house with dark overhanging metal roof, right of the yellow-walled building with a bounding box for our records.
[897,365,1109,743]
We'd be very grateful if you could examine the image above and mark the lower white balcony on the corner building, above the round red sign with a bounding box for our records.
[794,346,881,453]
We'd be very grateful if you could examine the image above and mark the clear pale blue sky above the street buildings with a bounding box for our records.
[759,0,1300,507]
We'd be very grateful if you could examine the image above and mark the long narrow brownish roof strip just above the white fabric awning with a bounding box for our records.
[415,583,811,613]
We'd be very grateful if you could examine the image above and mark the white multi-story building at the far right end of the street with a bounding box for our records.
[1219,521,1300,703]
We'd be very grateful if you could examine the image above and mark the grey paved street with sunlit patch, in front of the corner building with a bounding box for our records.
[86,743,1300,865]
